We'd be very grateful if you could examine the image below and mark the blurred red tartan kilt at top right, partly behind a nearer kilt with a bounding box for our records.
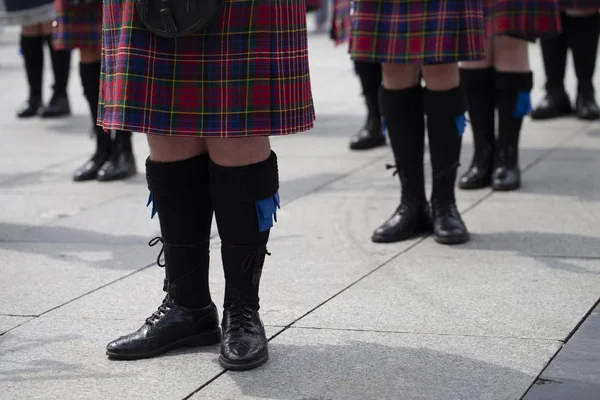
[486,0,562,39]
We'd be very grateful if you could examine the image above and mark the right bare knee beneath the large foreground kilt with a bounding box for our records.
[206,136,271,167]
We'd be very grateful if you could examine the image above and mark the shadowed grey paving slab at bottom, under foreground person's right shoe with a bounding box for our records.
[192,329,560,400]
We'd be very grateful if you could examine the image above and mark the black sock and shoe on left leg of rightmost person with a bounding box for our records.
[531,13,573,120]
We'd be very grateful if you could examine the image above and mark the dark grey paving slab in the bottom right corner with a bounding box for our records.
[524,307,600,400]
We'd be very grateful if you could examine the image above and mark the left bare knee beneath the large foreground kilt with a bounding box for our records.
[147,135,207,162]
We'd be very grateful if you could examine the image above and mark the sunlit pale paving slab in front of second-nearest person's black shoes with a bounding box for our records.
[298,252,600,340]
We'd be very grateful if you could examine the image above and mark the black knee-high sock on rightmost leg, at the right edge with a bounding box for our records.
[567,13,600,91]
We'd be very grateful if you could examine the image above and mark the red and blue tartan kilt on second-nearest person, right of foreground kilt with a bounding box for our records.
[350,0,485,65]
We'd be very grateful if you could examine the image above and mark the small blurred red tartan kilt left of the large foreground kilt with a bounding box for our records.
[53,0,102,51]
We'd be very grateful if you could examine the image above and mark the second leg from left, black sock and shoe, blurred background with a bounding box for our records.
[40,35,71,118]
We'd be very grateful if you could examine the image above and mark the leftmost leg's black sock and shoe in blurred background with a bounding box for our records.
[17,36,44,118]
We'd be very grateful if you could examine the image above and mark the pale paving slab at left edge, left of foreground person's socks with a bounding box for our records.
[0,241,155,315]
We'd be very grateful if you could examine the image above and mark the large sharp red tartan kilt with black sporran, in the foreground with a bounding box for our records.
[98,0,315,137]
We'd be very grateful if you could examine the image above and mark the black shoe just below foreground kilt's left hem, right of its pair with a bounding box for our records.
[97,131,137,182]
